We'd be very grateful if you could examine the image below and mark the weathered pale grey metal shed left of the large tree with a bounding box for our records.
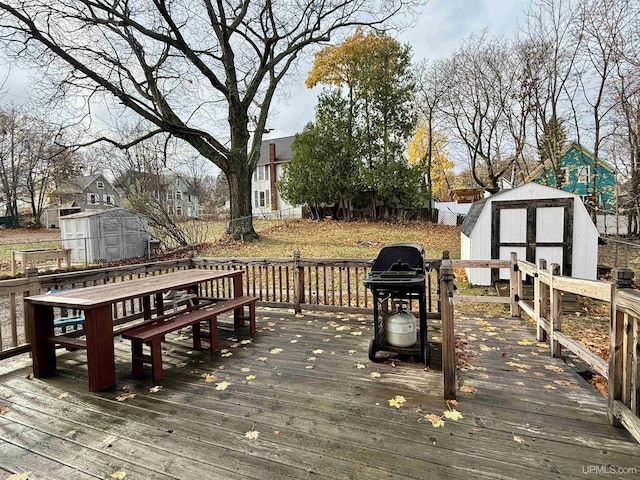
[60,208,149,263]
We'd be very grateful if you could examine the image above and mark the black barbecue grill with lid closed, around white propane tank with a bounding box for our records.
[363,243,429,365]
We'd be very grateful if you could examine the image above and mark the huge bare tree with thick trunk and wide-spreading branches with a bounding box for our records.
[0,0,422,239]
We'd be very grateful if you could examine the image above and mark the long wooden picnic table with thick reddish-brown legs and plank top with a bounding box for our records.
[24,269,255,392]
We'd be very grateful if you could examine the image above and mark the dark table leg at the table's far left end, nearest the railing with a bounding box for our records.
[24,302,56,378]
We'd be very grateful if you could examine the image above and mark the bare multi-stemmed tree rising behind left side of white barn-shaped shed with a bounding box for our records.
[443,34,527,193]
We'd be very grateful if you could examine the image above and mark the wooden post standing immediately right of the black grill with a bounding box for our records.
[439,250,456,400]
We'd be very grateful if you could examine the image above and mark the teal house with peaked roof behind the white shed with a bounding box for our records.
[526,142,616,213]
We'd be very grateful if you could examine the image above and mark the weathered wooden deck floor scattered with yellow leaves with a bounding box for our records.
[0,309,640,480]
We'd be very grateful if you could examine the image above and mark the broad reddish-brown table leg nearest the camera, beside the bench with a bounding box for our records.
[84,305,116,392]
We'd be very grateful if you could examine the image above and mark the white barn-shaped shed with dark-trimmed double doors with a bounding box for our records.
[460,183,599,285]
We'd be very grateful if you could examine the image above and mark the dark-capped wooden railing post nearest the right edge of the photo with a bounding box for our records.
[607,268,634,427]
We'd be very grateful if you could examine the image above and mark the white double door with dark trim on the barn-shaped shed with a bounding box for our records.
[491,198,573,279]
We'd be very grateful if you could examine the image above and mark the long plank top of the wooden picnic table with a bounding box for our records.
[24,269,242,309]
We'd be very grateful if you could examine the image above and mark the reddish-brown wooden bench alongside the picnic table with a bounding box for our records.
[122,297,258,382]
